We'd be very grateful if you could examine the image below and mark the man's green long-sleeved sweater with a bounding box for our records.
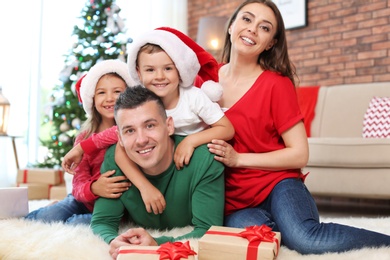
[91,136,225,245]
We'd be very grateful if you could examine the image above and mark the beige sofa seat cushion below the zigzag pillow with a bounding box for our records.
[307,137,390,168]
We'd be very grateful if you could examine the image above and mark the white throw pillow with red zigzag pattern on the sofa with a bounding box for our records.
[363,97,390,138]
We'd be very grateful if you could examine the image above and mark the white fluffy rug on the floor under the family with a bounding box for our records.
[0,201,390,260]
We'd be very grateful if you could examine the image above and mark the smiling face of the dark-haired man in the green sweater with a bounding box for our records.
[116,101,174,175]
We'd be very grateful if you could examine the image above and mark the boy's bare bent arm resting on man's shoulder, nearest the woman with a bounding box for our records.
[173,116,234,169]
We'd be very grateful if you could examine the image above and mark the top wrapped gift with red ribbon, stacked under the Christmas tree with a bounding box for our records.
[16,168,64,185]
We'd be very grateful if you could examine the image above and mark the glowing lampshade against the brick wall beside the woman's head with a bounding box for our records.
[196,16,228,57]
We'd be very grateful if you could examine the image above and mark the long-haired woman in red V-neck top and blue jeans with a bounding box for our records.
[208,0,390,254]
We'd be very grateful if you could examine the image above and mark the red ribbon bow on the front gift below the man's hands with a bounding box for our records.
[157,241,196,260]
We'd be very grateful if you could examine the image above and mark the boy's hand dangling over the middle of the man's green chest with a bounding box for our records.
[140,184,166,215]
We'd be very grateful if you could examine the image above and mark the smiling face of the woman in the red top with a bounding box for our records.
[229,3,278,56]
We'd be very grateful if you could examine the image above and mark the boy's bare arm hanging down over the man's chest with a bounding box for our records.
[115,144,166,214]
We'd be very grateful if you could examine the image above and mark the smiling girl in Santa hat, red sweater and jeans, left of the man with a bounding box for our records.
[26,60,134,224]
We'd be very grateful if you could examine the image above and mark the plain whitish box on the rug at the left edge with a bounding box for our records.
[0,187,28,219]
